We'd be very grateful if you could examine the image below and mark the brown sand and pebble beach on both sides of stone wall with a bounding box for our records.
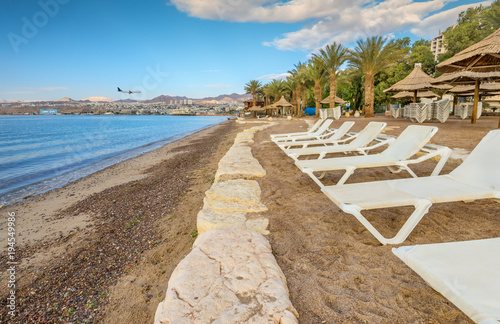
[0,116,500,323]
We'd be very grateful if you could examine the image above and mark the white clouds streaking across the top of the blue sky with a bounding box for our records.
[170,0,491,51]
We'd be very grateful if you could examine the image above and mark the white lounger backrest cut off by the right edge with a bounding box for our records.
[450,130,500,190]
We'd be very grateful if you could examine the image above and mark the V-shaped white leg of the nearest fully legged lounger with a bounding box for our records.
[339,199,432,245]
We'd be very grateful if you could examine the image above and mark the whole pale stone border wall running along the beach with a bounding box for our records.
[155,120,298,324]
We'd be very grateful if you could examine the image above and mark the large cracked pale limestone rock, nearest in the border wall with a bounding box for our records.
[155,229,298,324]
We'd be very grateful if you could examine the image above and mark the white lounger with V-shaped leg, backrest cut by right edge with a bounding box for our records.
[320,126,500,244]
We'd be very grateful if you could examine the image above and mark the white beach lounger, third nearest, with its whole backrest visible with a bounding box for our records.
[295,125,451,188]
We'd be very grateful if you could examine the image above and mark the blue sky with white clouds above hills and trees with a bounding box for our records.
[0,0,491,100]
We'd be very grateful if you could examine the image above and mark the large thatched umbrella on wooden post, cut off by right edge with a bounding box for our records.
[436,28,500,124]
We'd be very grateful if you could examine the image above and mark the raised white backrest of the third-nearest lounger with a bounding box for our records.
[380,125,438,161]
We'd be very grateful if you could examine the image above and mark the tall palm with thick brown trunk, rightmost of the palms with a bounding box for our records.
[349,36,401,117]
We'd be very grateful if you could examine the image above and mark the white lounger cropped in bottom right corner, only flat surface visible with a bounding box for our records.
[392,238,500,324]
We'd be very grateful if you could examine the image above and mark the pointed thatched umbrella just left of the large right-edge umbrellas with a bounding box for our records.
[384,64,451,102]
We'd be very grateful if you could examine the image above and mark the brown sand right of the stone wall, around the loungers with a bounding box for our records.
[253,117,500,323]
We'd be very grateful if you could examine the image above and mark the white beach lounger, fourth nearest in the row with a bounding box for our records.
[284,122,394,160]
